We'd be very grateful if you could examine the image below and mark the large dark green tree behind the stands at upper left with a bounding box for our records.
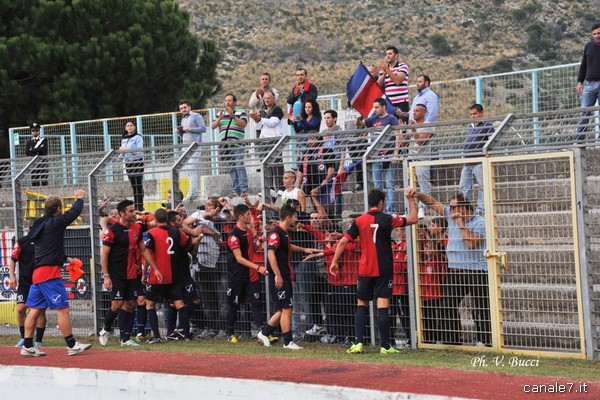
[0,0,220,157]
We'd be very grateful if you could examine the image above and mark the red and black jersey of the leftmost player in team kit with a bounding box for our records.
[102,222,142,280]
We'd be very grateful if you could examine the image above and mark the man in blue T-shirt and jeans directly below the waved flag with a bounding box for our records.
[355,97,400,214]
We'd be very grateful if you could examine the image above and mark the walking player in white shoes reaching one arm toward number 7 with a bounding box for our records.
[258,204,319,350]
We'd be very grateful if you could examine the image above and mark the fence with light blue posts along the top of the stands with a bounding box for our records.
[9,63,584,158]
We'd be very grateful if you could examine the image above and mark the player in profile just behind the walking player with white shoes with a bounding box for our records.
[227,204,267,343]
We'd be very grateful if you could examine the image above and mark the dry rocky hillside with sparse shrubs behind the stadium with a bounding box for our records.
[180,0,600,105]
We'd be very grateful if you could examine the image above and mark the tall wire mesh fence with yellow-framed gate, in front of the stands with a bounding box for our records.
[4,103,600,358]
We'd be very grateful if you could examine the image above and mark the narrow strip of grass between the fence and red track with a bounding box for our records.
[0,336,600,381]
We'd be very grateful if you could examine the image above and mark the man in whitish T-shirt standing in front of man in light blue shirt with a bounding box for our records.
[408,104,433,219]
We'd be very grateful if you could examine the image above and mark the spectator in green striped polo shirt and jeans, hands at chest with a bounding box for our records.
[211,93,248,198]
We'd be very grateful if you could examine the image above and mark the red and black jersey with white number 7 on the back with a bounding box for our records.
[344,210,406,276]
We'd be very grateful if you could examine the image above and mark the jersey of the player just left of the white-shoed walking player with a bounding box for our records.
[227,225,258,282]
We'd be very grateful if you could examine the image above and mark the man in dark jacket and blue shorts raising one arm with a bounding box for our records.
[21,190,92,357]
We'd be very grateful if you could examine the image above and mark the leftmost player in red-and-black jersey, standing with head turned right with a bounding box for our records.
[98,200,162,346]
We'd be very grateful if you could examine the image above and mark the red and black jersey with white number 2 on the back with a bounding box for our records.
[146,225,192,285]
